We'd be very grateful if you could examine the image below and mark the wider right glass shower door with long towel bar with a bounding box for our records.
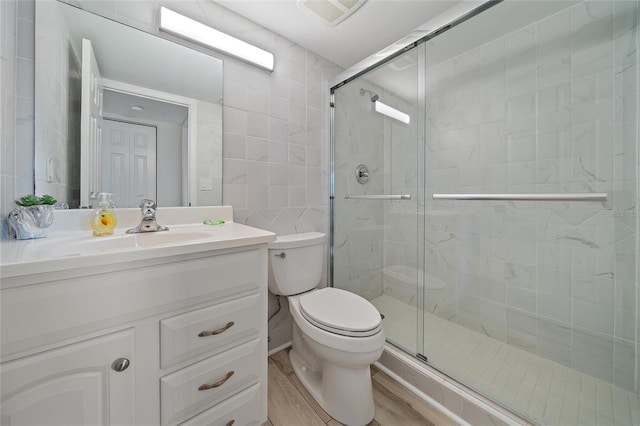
[421,0,640,425]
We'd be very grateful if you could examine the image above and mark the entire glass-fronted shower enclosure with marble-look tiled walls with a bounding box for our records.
[331,0,640,425]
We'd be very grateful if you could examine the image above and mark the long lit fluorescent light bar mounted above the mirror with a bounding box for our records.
[160,7,274,71]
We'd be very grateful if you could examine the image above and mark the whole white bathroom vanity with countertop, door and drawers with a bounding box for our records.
[0,207,275,426]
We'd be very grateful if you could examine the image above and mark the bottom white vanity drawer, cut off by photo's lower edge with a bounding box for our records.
[181,383,264,426]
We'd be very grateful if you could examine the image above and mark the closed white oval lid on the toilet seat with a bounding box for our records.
[300,287,382,337]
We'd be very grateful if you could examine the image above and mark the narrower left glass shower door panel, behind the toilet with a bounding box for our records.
[331,49,424,353]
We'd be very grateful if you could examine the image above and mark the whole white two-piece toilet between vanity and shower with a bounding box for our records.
[269,232,385,426]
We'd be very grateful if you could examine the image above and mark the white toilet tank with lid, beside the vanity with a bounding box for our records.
[269,232,325,296]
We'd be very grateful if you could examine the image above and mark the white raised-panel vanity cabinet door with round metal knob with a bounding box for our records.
[0,329,135,426]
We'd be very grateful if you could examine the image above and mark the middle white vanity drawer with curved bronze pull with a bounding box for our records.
[160,339,267,425]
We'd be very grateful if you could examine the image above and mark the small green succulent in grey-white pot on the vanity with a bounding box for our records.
[7,194,57,240]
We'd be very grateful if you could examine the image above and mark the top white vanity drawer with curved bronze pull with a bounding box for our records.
[160,293,265,368]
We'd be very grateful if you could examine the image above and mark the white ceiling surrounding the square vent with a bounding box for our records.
[212,0,461,68]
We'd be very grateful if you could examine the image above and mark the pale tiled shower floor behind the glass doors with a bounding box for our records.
[371,295,640,426]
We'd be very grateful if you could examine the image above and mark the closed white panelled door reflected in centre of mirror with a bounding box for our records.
[100,119,157,207]
